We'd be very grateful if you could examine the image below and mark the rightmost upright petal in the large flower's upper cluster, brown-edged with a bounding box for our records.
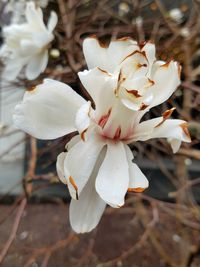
[151,61,180,107]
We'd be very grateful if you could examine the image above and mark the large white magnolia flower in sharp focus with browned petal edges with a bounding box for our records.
[13,38,190,233]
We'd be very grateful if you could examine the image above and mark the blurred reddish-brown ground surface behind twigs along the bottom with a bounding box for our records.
[0,204,200,267]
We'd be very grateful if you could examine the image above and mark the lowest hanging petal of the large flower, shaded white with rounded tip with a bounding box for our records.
[69,174,106,233]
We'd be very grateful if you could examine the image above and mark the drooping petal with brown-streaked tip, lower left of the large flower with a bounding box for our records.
[64,136,105,199]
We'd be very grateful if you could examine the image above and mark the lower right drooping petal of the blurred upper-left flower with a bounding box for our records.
[26,50,48,80]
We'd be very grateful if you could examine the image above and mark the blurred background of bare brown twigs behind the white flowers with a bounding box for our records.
[0,0,200,267]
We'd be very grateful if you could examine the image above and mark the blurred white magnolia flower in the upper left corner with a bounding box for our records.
[0,2,57,80]
